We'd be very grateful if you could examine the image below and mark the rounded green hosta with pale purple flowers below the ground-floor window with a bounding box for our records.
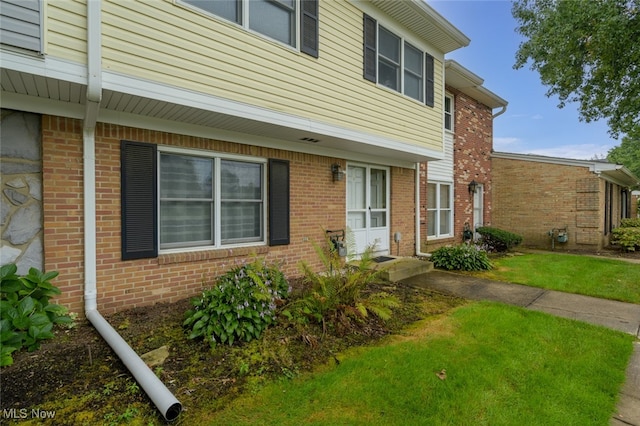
[183,260,289,347]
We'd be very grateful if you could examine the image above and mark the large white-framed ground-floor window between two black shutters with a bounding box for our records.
[158,150,266,250]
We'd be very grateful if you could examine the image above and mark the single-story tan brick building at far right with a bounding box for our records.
[492,152,640,250]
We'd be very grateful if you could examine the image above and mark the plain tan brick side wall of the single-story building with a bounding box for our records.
[493,158,604,249]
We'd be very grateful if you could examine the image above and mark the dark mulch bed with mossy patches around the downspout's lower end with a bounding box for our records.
[0,282,465,426]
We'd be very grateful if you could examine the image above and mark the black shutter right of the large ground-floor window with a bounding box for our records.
[269,158,290,246]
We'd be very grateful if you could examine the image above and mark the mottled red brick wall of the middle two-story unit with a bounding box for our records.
[420,86,494,251]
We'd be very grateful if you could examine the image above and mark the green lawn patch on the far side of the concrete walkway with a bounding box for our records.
[473,253,640,304]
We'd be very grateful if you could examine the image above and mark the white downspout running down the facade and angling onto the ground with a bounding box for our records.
[82,0,182,421]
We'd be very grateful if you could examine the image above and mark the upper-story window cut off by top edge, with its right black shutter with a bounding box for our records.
[182,0,318,57]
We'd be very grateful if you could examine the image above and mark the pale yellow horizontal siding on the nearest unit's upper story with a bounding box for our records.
[46,0,443,151]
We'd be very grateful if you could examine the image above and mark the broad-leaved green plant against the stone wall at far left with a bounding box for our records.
[0,264,73,367]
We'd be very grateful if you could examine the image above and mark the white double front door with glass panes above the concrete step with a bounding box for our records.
[347,165,389,256]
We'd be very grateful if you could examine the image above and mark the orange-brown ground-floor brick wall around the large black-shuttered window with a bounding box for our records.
[43,116,415,313]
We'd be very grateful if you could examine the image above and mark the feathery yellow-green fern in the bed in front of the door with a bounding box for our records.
[290,240,400,329]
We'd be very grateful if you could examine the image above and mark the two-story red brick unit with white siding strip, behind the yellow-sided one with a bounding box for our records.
[420,60,507,251]
